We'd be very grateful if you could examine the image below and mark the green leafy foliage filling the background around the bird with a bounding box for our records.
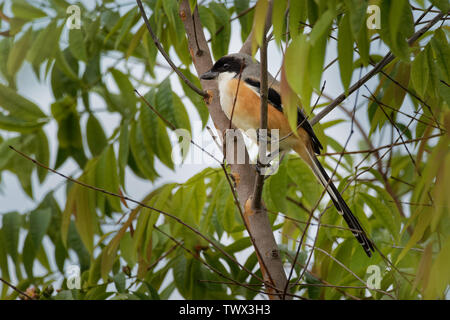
[0,0,450,299]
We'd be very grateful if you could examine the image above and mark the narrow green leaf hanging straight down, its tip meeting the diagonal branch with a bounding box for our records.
[338,15,353,94]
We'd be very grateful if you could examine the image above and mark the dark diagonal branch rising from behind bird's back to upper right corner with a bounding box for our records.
[310,12,445,125]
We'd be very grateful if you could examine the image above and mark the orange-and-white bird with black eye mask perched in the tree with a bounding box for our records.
[200,53,375,258]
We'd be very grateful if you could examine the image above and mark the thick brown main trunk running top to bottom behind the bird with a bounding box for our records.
[180,0,286,296]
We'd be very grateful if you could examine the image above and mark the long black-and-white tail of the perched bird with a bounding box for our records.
[295,146,375,257]
